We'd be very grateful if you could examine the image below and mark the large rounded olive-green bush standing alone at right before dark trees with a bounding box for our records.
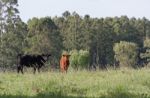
[113,41,138,67]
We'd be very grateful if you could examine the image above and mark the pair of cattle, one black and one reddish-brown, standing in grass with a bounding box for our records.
[17,54,70,74]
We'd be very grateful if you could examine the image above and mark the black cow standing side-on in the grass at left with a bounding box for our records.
[17,54,51,74]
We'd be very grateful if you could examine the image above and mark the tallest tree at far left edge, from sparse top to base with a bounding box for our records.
[0,0,23,67]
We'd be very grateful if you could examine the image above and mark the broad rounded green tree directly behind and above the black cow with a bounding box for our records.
[25,17,62,63]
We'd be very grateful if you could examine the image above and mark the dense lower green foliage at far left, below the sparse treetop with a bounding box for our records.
[0,21,27,66]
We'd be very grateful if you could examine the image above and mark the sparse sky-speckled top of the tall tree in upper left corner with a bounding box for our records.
[0,0,19,33]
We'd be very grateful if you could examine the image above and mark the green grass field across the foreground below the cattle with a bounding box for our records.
[0,69,150,98]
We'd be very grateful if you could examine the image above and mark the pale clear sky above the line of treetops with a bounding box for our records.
[18,0,150,22]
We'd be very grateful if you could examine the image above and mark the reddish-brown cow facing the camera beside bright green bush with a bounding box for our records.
[60,54,70,72]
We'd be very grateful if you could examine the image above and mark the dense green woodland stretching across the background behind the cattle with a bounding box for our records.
[0,0,150,68]
